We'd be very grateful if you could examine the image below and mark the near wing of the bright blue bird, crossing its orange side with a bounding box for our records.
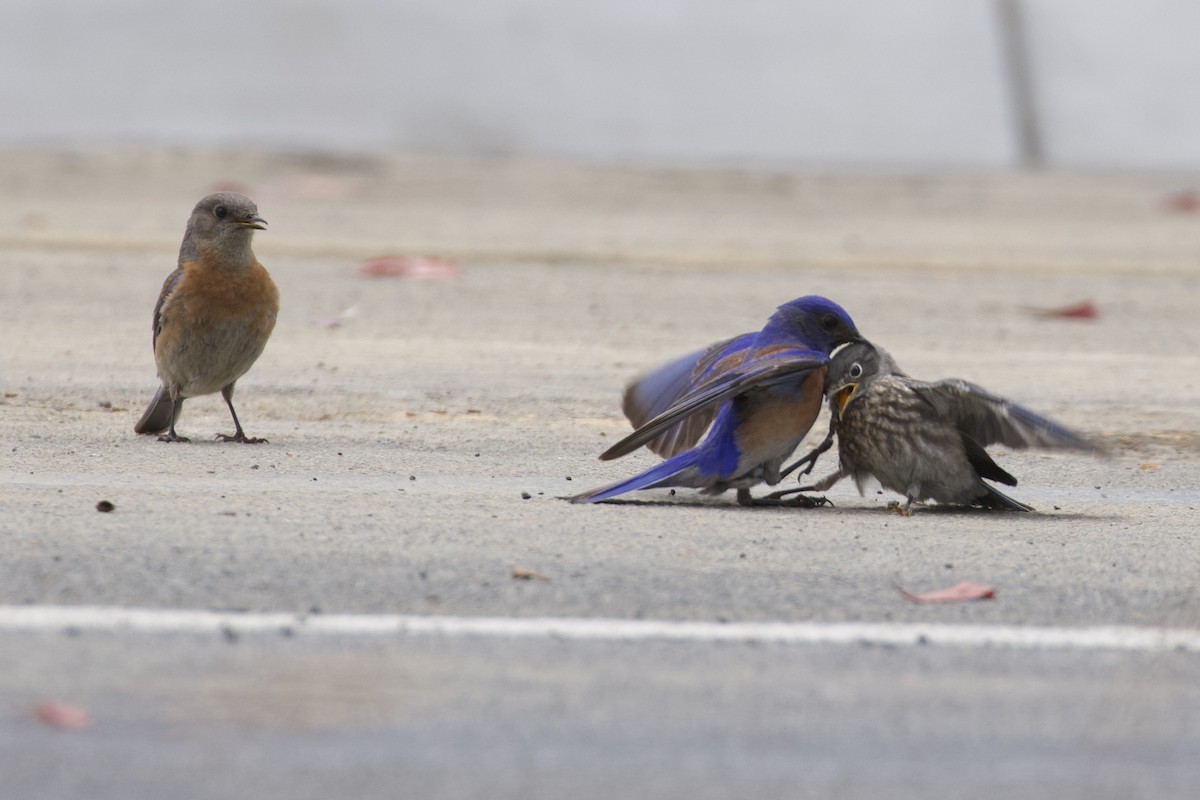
[600,347,829,461]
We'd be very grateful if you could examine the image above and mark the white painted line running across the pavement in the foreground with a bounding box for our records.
[0,606,1200,652]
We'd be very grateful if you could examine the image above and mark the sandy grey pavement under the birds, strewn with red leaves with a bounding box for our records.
[0,151,1200,798]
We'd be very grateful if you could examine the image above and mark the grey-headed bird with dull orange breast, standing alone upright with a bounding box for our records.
[133,192,280,444]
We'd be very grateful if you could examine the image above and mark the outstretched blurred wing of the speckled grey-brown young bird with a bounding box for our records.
[911,378,1102,453]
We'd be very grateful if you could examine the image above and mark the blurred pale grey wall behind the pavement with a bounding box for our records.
[0,0,1200,169]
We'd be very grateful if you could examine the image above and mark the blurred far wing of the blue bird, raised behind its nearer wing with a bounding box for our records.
[622,333,755,458]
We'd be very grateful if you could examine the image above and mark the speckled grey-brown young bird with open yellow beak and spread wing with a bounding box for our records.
[779,341,1099,517]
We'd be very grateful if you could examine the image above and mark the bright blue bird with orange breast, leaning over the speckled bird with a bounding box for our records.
[568,295,859,505]
